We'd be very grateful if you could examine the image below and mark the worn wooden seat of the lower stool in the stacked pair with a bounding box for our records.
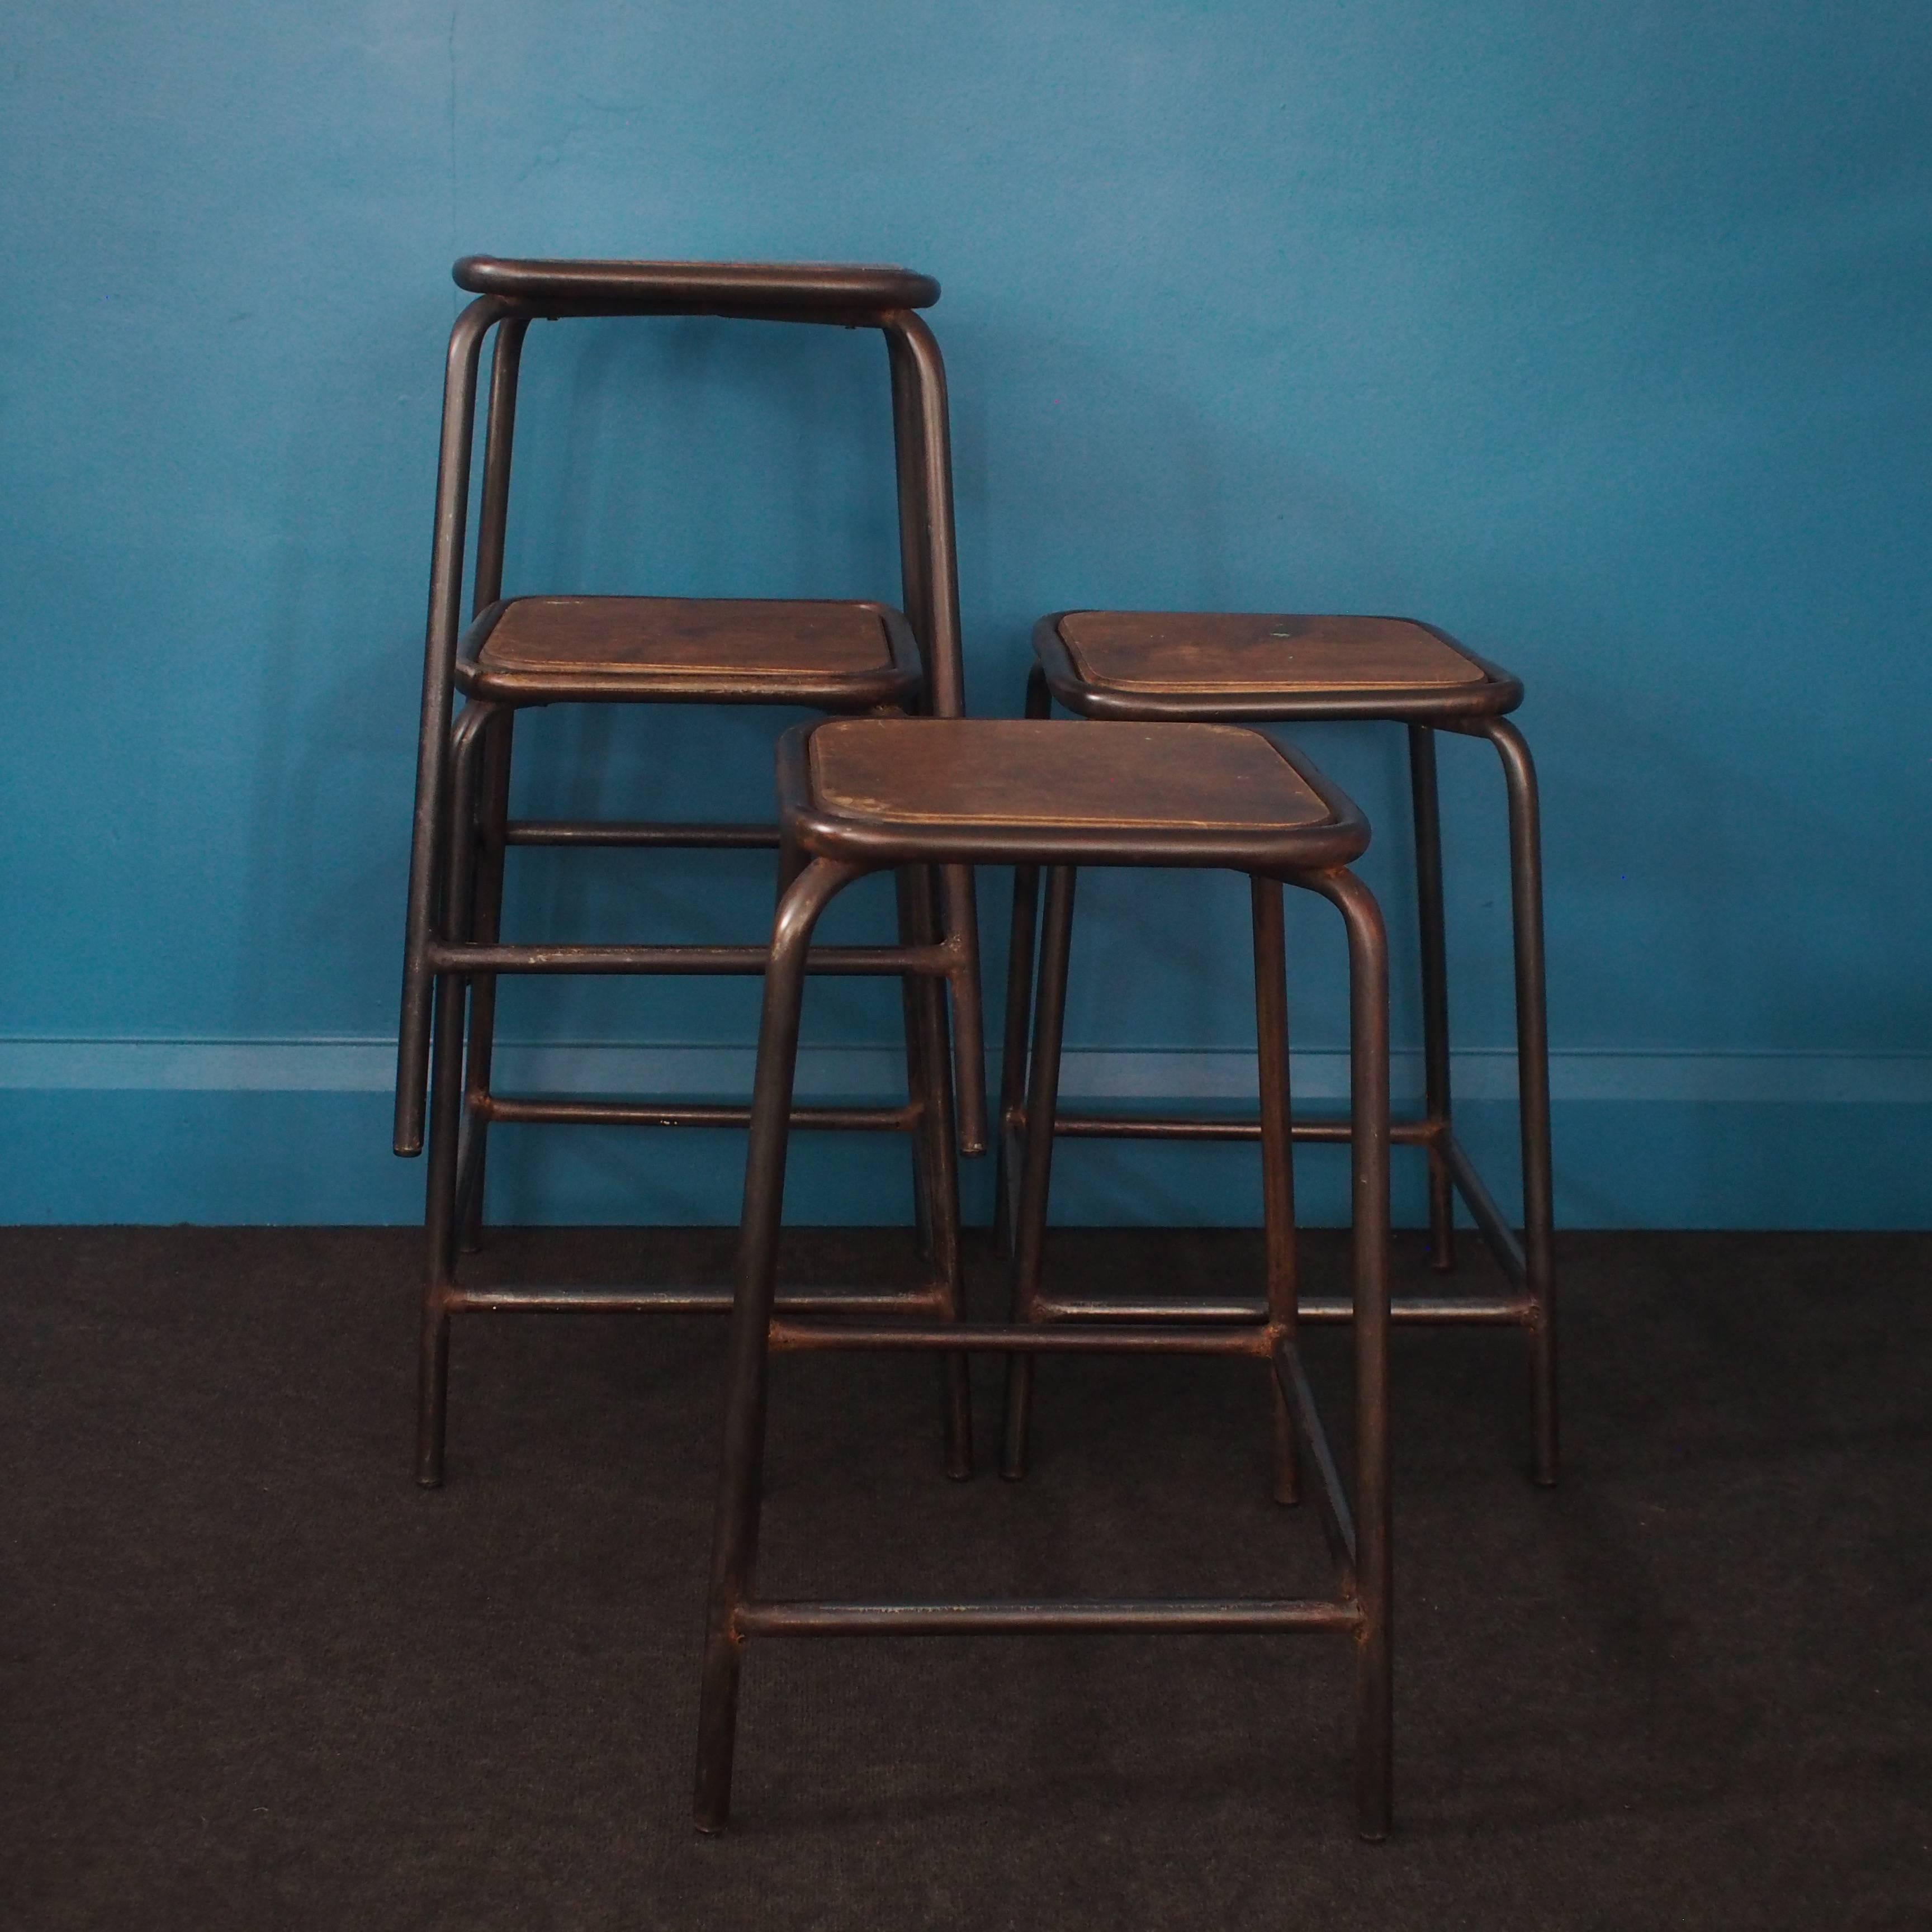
[462,597,920,711]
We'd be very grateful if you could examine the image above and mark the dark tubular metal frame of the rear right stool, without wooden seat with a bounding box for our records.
[995,641,1557,1486]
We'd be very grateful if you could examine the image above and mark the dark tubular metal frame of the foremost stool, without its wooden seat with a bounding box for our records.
[695,726,1393,1839]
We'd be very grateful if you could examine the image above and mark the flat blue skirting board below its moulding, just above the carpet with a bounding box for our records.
[0,1090,1932,1238]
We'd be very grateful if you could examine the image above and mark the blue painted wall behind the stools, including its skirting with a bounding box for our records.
[0,0,1932,1225]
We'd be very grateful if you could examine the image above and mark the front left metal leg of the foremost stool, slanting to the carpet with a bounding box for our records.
[695,860,860,1831]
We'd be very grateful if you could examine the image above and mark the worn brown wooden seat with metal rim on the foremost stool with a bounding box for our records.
[779,717,1368,872]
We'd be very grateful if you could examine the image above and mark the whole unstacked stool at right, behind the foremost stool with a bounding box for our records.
[999,610,1557,1484]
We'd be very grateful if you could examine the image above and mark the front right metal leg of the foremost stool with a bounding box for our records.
[1319,872,1395,1839]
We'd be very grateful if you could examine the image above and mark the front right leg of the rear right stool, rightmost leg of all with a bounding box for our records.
[1484,719,1557,1484]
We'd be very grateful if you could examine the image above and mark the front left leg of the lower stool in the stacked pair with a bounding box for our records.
[415,705,495,1490]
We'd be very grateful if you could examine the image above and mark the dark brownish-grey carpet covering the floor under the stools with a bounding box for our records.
[0,1229,1932,1932]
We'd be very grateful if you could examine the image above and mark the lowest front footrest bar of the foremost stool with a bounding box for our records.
[732,1598,1362,1636]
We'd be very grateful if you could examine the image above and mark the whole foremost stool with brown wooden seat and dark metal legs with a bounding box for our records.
[698,719,1391,1838]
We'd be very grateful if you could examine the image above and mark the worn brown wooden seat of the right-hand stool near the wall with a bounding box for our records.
[1034,610,1522,721]
